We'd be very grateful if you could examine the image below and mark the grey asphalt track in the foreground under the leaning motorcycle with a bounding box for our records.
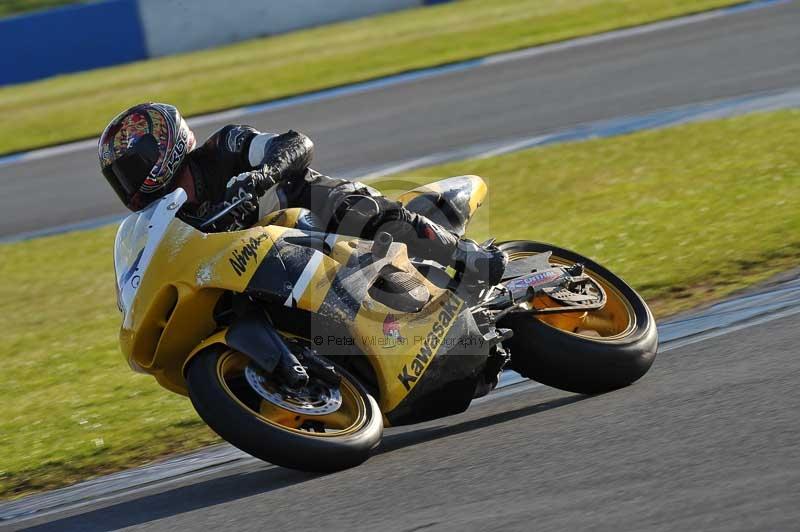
[11,302,800,532]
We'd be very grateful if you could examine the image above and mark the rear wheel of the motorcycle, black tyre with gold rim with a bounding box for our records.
[498,240,658,394]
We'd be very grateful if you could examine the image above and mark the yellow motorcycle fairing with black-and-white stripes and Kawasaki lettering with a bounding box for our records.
[115,178,488,424]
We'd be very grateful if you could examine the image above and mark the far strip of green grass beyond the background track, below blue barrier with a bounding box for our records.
[0,0,737,153]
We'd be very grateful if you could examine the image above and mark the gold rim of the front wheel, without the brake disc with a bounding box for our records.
[217,351,367,438]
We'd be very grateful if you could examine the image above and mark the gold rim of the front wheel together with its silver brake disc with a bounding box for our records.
[217,351,367,438]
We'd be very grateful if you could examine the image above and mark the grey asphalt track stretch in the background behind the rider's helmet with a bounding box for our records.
[0,2,800,237]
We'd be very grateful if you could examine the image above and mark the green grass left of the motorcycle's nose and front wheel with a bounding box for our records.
[0,227,220,497]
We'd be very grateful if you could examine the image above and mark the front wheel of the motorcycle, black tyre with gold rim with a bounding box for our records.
[186,346,383,472]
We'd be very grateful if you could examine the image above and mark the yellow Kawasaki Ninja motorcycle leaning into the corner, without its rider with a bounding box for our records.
[114,176,658,471]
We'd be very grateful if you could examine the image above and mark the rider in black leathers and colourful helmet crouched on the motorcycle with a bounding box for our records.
[99,103,507,284]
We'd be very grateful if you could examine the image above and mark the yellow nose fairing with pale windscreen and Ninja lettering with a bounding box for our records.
[115,190,287,394]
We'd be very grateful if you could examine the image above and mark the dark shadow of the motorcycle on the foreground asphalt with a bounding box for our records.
[26,395,587,532]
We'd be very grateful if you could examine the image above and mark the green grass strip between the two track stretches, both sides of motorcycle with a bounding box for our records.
[0,111,800,497]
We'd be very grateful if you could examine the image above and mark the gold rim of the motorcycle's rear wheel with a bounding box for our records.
[507,251,636,341]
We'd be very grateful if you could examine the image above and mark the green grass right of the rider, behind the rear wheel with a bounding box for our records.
[386,110,800,316]
